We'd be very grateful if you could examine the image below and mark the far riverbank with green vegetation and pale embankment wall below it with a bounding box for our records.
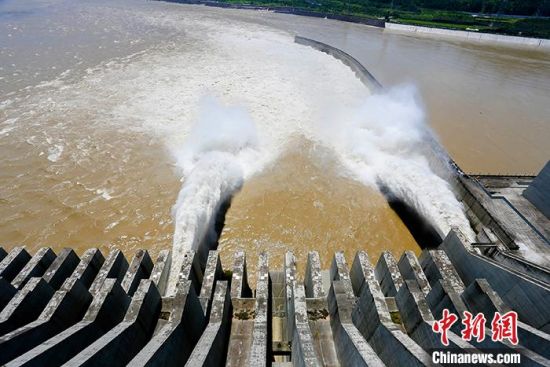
[158,0,550,43]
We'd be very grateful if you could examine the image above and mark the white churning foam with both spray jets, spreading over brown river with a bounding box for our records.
[0,0,478,289]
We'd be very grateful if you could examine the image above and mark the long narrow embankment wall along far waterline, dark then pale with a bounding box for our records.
[158,0,550,50]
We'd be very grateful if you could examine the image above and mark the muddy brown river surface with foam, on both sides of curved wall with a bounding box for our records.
[0,0,550,278]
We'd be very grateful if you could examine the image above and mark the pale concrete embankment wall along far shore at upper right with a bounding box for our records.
[385,22,550,50]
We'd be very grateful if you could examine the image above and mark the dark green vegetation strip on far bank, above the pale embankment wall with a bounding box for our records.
[219,0,550,38]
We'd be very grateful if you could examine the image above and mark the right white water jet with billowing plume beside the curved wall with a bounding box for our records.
[314,86,475,240]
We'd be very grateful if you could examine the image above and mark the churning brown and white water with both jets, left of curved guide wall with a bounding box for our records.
[0,0,548,284]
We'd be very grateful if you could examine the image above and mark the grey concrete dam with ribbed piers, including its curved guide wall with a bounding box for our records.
[0,37,550,366]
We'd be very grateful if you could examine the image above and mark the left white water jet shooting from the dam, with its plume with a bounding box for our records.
[167,98,265,294]
